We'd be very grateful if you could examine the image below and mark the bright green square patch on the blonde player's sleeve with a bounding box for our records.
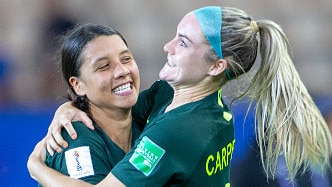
[129,136,165,176]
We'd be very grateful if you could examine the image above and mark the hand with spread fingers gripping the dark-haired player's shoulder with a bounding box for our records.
[45,102,94,155]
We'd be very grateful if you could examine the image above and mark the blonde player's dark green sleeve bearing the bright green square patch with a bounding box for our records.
[111,136,177,186]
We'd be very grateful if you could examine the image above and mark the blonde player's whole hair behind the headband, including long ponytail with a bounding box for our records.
[210,7,332,181]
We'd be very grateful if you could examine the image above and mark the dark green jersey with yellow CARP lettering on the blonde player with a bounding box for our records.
[112,81,235,186]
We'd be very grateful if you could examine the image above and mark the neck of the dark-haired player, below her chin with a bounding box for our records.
[91,106,132,153]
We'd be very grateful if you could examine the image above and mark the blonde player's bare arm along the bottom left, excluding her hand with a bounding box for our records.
[27,138,125,187]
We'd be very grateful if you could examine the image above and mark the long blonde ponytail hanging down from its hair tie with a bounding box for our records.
[248,20,331,180]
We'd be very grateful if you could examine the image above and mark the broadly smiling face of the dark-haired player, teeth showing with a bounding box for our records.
[70,34,140,112]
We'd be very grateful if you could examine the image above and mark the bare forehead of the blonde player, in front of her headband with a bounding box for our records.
[177,12,205,43]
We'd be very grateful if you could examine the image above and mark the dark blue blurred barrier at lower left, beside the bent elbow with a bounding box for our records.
[0,105,55,187]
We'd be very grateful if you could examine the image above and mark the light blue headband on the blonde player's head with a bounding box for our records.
[194,6,223,59]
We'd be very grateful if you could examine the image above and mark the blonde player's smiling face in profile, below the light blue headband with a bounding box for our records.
[159,12,211,85]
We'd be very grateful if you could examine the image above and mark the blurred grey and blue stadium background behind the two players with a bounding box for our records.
[0,0,332,186]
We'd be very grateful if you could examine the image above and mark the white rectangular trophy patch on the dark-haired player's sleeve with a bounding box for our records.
[65,146,94,179]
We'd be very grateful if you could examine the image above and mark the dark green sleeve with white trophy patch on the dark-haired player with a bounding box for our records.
[45,122,111,184]
